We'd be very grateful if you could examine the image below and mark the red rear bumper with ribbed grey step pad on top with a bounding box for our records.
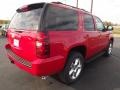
[5,44,64,76]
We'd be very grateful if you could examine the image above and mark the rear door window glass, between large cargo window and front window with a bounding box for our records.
[84,15,94,31]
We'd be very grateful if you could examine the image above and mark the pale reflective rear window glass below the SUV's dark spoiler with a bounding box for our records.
[9,8,42,30]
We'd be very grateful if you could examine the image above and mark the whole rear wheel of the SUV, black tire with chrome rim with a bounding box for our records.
[59,52,84,84]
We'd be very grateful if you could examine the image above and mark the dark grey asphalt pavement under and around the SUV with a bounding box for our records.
[0,37,120,90]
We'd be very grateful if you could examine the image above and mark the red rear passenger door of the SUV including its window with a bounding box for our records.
[83,14,100,58]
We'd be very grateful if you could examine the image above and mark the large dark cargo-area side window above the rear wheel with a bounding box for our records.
[44,5,78,30]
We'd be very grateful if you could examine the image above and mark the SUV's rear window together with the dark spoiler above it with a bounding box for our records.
[9,4,44,30]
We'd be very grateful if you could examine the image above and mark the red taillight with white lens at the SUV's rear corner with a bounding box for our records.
[36,32,50,58]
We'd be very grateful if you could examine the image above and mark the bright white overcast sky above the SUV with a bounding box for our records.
[0,0,120,24]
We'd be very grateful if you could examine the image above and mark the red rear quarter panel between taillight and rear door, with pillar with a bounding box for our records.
[48,13,87,67]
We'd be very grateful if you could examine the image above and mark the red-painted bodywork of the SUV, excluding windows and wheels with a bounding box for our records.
[5,4,113,76]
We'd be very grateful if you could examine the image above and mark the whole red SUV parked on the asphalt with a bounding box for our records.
[5,2,114,84]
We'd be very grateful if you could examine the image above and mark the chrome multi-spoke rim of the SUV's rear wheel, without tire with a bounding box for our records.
[69,58,82,80]
